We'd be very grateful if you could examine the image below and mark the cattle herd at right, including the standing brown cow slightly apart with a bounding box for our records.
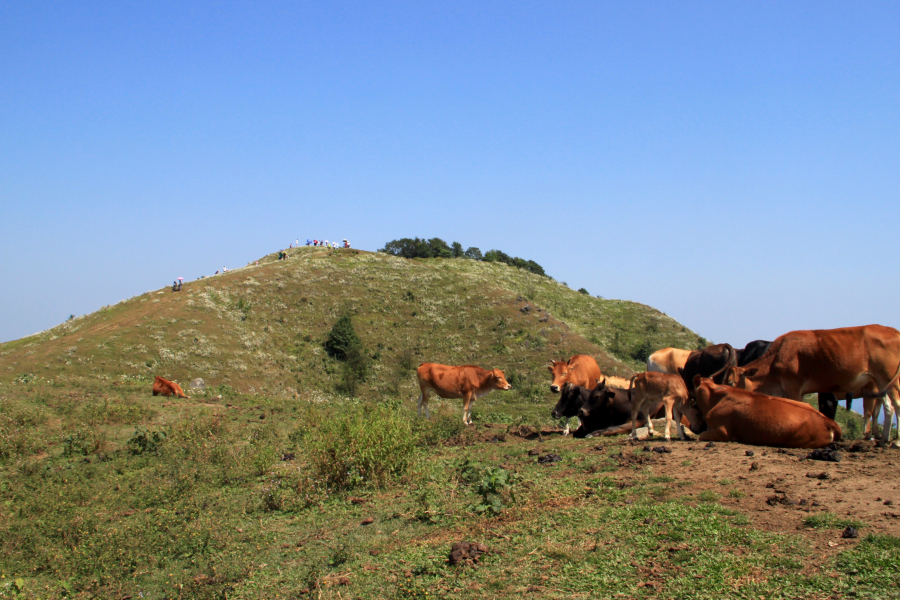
[416,325,900,448]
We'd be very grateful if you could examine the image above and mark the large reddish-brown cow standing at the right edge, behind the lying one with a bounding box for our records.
[723,325,900,445]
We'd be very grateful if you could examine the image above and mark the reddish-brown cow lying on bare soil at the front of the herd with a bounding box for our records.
[693,375,841,448]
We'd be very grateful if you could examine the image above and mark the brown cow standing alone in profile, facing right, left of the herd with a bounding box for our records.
[416,363,512,425]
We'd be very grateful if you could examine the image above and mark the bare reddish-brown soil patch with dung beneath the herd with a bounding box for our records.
[506,429,900,556]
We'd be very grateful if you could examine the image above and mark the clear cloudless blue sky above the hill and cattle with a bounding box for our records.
[0,1,900,345]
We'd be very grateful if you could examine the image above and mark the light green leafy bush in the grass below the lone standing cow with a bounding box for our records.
[300,405,419,490]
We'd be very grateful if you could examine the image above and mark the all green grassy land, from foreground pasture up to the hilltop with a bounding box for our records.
[0,248,876,599]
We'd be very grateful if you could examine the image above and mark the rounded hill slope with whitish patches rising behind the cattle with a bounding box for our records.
[0,247,699,395]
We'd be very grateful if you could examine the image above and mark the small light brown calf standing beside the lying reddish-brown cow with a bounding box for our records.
[629,372,702,441]
